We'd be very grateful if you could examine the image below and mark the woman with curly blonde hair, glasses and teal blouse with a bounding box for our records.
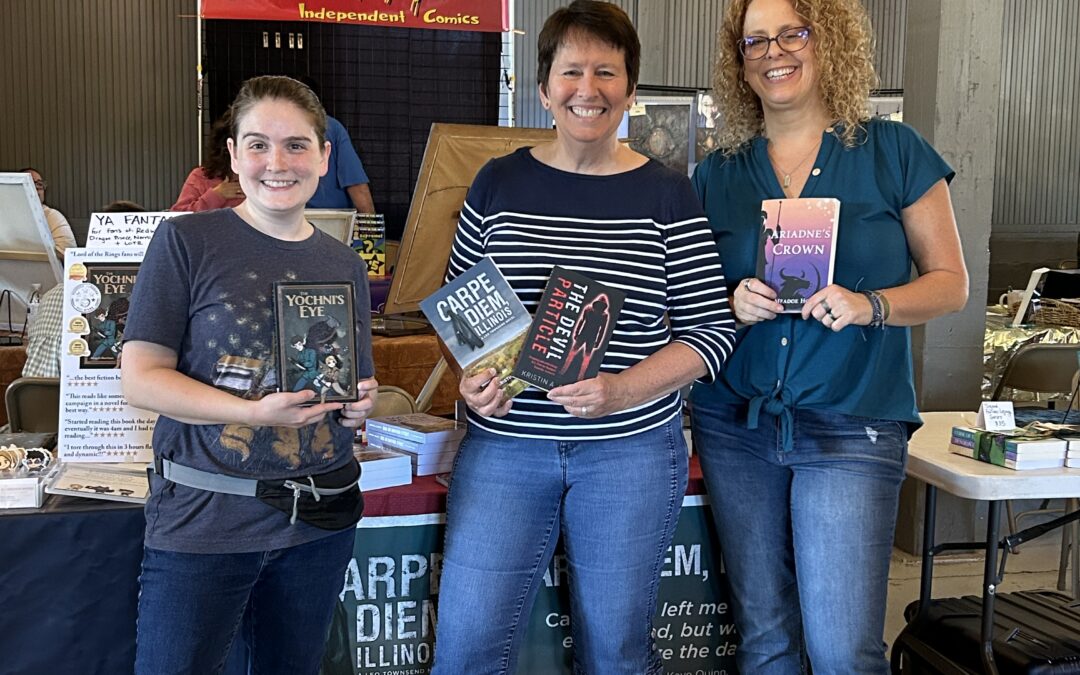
[691,0,968,675]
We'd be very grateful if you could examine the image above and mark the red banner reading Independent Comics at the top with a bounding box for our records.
[202,0,510,32]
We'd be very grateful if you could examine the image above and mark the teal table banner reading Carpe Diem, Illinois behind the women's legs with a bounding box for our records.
[322,496,738,675]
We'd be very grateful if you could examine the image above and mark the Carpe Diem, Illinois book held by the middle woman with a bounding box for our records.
[420,258,532,397]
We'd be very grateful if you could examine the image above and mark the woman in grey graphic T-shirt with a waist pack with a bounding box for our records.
[122,77,378,675]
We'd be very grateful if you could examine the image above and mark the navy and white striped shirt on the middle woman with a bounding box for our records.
[446,148,734,441]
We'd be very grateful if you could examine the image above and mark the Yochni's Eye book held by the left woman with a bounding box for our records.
[274,282,359,403]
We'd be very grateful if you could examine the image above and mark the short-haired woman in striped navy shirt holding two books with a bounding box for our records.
[432,0,734,675]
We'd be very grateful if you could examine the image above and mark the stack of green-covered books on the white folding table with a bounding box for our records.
[949,427,1068,471]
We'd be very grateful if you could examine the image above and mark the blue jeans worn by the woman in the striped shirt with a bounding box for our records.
[432,417,687,675]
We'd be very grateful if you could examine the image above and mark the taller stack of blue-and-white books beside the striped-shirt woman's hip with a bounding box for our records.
[367,413,465,476]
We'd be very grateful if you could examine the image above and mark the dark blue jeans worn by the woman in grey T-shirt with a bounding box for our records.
[135,527,356,675]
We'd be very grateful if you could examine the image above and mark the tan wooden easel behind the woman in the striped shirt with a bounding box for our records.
[386,123,555,410]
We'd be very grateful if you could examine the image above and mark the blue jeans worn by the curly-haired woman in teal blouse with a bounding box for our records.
[693,405,907,675]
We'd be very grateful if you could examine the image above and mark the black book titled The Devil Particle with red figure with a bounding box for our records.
[514,267,626,390]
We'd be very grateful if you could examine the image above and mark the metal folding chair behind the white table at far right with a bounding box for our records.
[991,345,1080,597]
